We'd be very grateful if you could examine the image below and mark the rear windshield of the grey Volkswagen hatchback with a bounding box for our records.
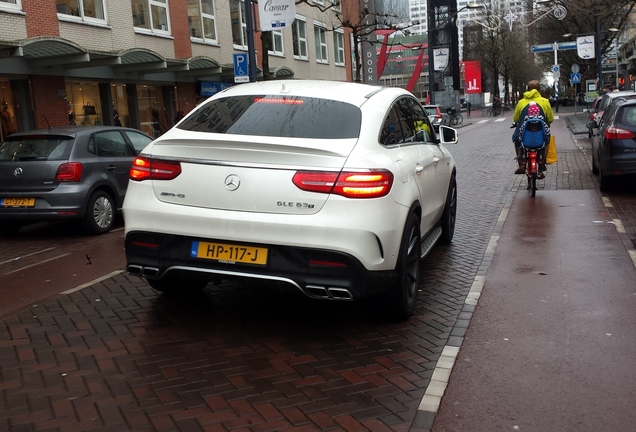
[0,136,73,162]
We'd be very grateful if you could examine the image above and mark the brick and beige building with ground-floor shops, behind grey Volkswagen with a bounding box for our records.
[0,0,351,138]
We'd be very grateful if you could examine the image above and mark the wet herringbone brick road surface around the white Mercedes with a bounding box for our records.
[0,112,633,431]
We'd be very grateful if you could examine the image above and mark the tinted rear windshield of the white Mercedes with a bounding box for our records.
[177,95,362,139]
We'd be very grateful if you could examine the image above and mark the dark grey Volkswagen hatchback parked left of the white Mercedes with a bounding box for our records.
[0,126,152,234]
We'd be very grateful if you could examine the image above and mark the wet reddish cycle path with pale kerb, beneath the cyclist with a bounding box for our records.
[418,107,636,432]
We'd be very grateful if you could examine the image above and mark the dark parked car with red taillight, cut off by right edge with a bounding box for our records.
[588,97,636,191]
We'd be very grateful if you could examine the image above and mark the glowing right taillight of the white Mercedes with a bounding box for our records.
[292,170,393,198]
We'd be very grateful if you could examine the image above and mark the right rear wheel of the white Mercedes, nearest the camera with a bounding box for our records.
[388,213,422,320]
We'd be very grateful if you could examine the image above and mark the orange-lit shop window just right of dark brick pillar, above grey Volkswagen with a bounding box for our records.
[66,81,103,126]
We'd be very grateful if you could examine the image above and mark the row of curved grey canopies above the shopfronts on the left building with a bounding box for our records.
[0,37,222,77]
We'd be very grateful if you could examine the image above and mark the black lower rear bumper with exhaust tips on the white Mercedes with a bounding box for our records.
[125,231,396,300]
